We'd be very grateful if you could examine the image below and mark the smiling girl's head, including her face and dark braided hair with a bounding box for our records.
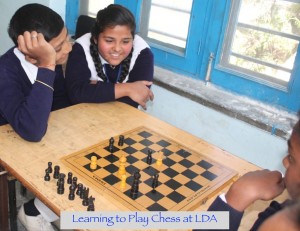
[90,4,136,82]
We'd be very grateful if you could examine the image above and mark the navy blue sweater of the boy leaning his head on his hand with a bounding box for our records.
[0,48,70,142]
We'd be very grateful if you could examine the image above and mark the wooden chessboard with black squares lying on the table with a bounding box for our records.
[62,127,237,211]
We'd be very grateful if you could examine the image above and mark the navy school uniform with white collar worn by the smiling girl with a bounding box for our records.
[66,33,154,107]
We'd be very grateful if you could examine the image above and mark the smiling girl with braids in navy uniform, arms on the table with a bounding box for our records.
[66,4,154,109]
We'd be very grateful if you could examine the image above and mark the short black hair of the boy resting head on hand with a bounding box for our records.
[8,3,64,45]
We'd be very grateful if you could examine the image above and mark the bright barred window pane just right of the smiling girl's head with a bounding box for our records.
[141,0,192,53]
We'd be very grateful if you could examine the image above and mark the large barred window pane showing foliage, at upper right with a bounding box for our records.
[220,0,300,90]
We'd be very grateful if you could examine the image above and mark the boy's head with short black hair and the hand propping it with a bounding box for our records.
[8,3,72,69]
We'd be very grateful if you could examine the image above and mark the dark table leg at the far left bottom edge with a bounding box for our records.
[0,166,9,230]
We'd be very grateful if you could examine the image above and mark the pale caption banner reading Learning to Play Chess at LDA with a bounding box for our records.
[60,211,229,229]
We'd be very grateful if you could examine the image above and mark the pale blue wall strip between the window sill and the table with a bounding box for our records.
[147,85,287,171]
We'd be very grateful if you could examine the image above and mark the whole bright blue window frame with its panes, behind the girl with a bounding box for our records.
[67,0,300,112]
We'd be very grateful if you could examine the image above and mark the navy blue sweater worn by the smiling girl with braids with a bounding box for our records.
[66,33,154,107]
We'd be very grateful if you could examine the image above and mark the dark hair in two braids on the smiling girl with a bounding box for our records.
[90,4,136,83]
